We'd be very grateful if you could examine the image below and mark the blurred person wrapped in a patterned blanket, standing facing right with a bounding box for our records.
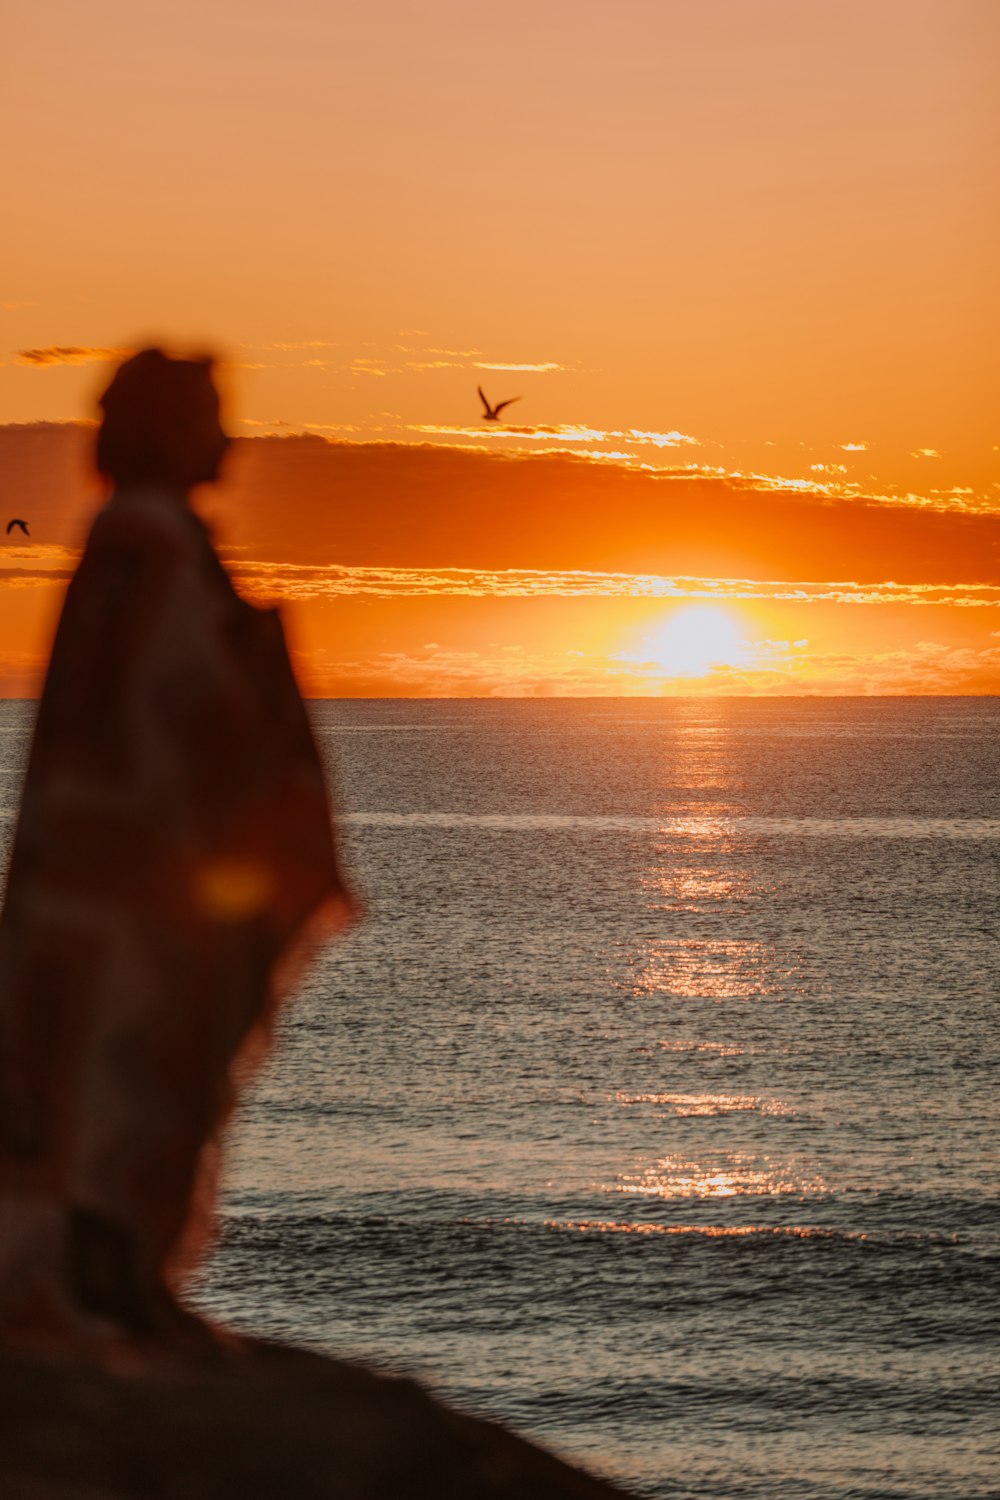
[0,348,354,1343]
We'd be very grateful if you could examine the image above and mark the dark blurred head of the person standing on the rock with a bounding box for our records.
[96,350,229,491]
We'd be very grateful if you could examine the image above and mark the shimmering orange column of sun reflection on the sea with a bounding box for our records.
[611,723,828,1238]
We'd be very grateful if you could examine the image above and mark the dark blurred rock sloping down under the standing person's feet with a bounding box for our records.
[0,1343,632,1500]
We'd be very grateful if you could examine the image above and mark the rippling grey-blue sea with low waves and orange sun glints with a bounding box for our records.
[0,699,1000,1500]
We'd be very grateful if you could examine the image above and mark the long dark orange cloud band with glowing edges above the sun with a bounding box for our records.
[0,425,1000,591]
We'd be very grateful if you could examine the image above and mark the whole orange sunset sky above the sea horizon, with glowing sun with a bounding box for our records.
[0,0,1000,696]
